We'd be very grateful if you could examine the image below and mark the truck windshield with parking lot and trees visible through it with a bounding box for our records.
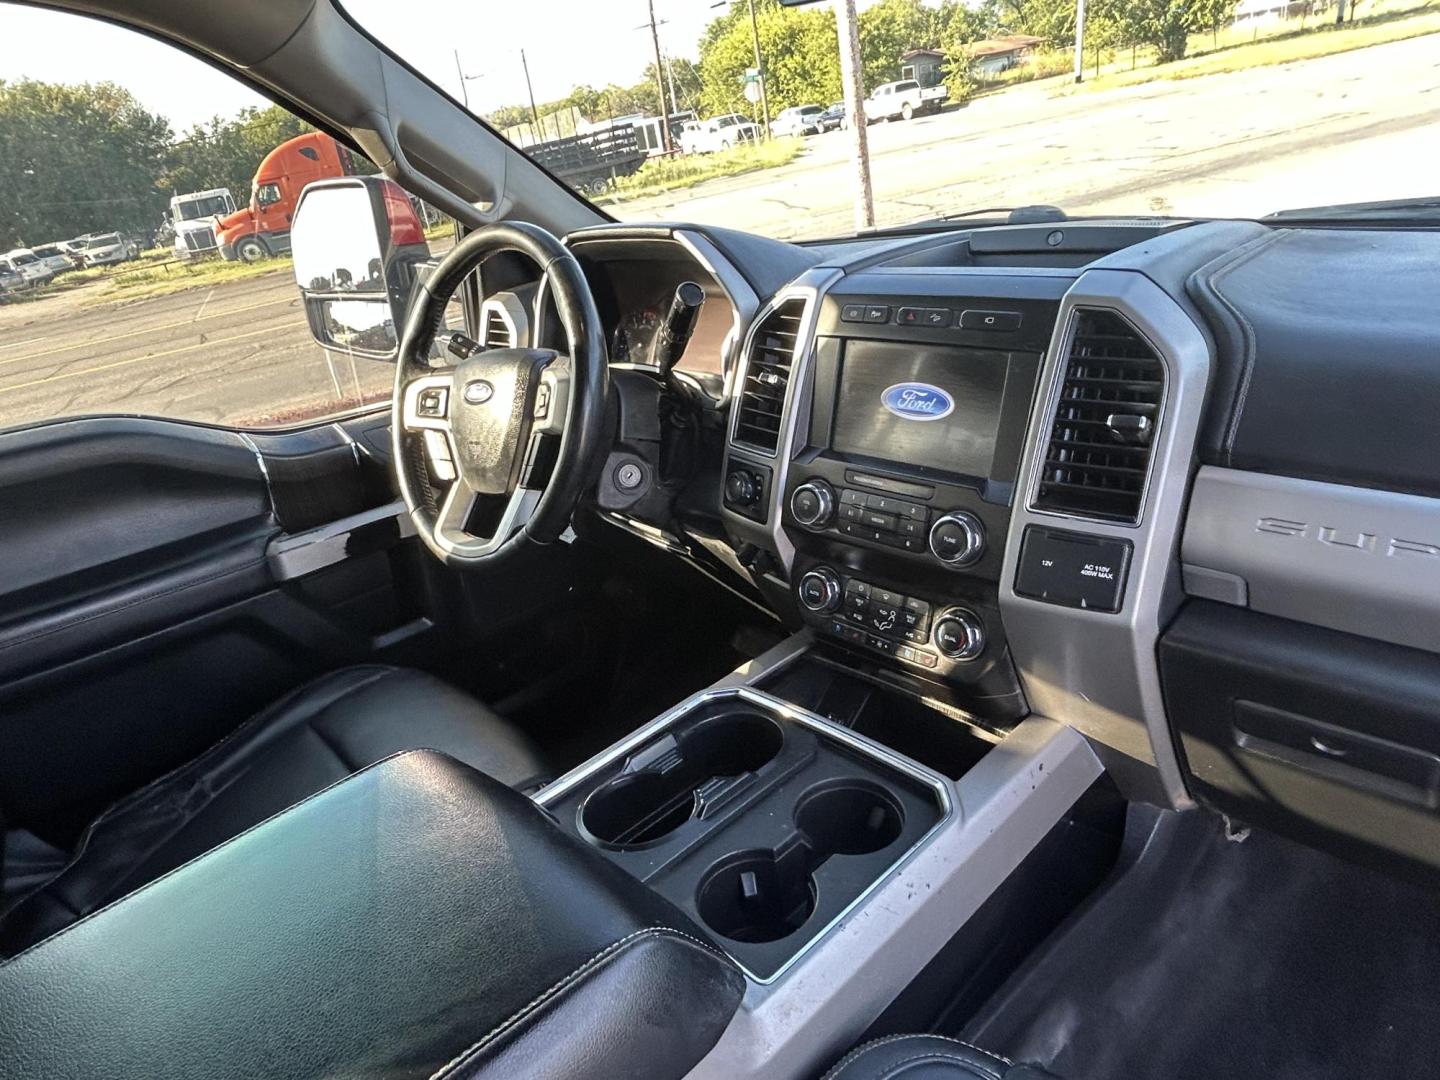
[341,0,1440,238]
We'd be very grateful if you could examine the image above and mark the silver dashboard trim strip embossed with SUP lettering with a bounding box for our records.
[1182,467,1440,651]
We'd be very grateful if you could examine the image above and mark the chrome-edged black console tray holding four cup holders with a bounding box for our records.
[543,687,952,984]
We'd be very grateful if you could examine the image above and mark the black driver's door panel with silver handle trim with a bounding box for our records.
[0,416,444,845]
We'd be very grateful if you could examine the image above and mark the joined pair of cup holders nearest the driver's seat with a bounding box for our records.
[580,713,785,848]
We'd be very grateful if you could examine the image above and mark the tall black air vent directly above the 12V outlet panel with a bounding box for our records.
[1035,310,1165,524]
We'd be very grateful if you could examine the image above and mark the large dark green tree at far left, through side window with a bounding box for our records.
[0,79,171,251]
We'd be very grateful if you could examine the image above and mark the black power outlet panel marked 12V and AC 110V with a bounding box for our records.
[1015,526,1133,613]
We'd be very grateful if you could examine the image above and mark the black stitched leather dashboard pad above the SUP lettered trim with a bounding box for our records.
[1187,229,1440,495]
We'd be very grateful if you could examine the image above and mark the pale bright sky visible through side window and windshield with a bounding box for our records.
[0,0,812,132]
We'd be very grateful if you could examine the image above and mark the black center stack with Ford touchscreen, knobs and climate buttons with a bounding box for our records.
[726,271,1071,726]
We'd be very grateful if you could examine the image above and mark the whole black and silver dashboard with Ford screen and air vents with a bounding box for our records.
[535,220,1440,878]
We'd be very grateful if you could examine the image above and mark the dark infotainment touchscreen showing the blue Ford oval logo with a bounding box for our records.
[831,340,1011,477]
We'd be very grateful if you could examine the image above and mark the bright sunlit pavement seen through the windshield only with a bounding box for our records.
[613,35,1440,238]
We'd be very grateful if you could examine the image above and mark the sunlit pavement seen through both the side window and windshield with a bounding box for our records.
[0,36,1440,426]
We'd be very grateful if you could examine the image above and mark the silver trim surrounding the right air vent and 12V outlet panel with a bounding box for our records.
[999,269,1211,808]
